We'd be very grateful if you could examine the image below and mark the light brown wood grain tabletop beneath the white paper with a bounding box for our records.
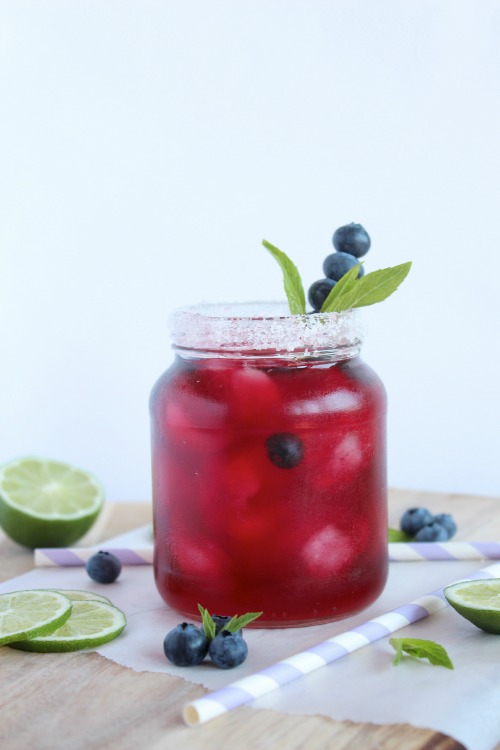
[0,490,500,750]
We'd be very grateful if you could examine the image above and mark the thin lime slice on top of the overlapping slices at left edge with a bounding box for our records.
[0,589,72,646]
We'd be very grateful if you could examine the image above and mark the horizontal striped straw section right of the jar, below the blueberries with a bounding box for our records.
[389,542,500,562]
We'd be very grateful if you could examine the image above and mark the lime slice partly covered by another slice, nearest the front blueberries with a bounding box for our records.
[9,600,127,651]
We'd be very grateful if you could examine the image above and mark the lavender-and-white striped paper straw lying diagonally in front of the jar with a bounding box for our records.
[182,563,500,727]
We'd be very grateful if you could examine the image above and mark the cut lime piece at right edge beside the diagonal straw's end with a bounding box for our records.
[443,578,500,633]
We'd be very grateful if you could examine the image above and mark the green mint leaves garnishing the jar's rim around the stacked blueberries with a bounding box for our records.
[262,240,411,315]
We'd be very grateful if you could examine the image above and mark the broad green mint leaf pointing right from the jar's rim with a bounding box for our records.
[321,261,411,312]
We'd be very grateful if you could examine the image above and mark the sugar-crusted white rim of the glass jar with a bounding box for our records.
[170,302,362,358]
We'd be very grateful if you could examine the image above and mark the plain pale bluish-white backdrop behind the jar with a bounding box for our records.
[0,0,500,500]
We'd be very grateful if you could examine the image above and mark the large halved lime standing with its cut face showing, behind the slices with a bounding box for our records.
[0,458,104,549]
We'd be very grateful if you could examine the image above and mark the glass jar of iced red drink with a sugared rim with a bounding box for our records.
[150,303,388,627]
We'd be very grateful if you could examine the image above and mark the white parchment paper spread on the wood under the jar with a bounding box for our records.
[0,529,500,750]
